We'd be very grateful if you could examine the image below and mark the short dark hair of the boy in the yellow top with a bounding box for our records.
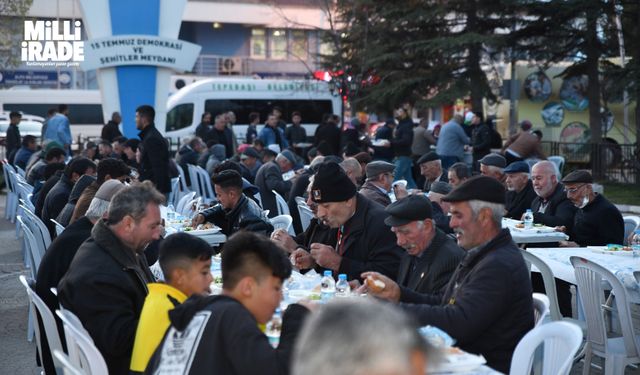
[158,233,213,282]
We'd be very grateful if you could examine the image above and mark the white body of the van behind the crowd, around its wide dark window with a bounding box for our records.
[160,78,342,142]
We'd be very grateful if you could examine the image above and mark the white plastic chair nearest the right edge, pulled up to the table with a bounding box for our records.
[569,256,640,374]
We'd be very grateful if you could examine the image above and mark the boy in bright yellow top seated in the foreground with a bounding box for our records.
[130,233,213,373]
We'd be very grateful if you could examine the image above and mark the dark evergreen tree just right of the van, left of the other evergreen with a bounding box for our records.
[325,0,513,113]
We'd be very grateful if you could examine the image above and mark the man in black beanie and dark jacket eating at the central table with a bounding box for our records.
[292,162,404,280]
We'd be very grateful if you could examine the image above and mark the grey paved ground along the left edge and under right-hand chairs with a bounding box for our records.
[0,194,640,375]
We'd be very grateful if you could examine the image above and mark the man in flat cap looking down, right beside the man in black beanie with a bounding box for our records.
[384,195,465,301]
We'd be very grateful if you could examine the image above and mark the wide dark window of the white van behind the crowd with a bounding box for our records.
[204,99,334,124]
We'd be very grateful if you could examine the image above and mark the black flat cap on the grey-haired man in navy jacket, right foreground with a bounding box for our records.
[442,175,506,204]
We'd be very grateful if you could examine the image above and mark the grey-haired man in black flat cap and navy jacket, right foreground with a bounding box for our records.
[362,176,534,373]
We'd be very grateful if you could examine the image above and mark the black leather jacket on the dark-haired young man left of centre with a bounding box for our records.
[201,194,273,236]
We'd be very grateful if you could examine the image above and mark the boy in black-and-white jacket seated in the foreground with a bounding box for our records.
[145,231,309,375]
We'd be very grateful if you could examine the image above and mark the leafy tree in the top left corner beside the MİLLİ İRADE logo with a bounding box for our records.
[0,0,33,68]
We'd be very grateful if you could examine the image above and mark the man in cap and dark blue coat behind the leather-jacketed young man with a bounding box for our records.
[255,148,296,218]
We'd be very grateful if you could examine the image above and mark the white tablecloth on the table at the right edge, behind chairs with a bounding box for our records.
[527,247,640,303]
